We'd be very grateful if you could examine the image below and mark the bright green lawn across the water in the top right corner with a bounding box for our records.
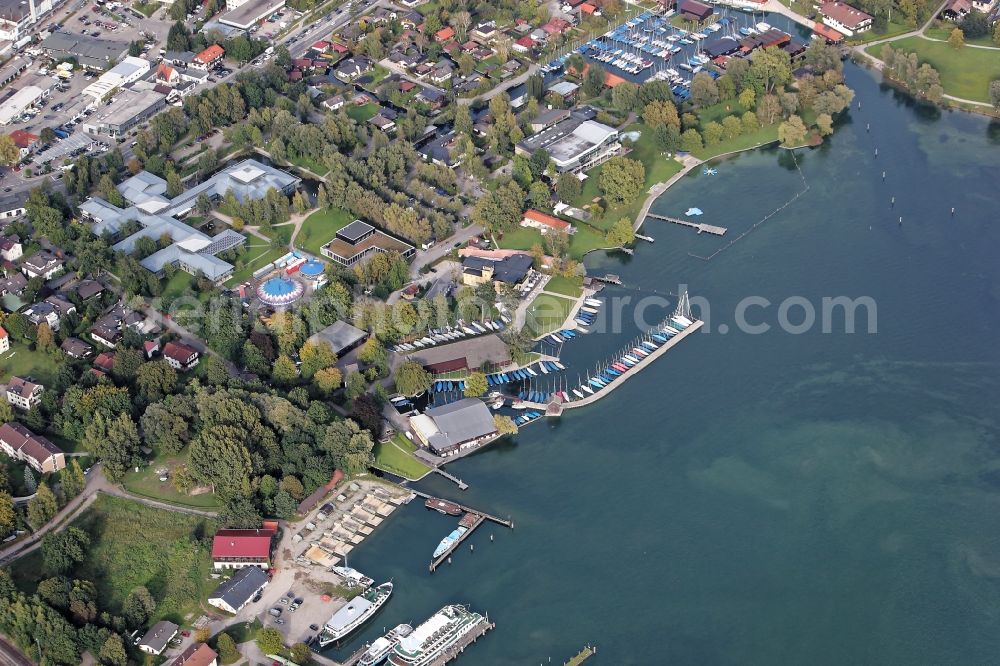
[867,37,1000,102]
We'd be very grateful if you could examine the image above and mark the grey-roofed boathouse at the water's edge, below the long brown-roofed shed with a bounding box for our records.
[410,398,497,456]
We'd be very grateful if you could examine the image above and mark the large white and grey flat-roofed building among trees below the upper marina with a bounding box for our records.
[515,113,622,172]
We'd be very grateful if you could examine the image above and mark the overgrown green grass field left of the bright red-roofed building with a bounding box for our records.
[12,494,218,624]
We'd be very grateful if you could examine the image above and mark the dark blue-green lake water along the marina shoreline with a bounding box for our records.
[328,66,1000,666]
